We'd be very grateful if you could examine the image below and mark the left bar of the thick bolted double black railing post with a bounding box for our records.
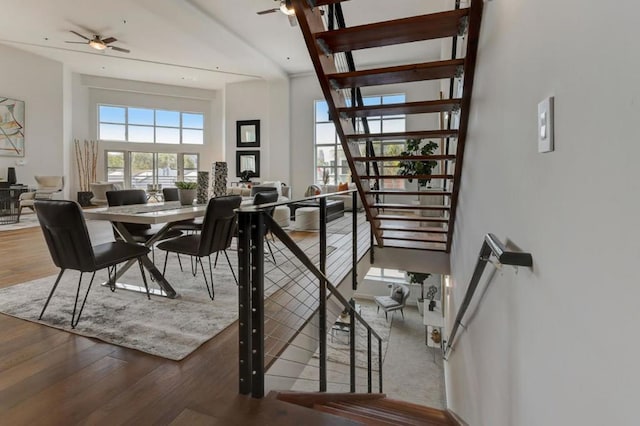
[238,212,251,395]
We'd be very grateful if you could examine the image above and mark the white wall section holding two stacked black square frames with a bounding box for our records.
[225,79,291,185]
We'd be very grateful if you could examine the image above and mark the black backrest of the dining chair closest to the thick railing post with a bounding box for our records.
[198,195,242,256]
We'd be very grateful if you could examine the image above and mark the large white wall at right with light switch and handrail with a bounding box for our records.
[446,0,640,426]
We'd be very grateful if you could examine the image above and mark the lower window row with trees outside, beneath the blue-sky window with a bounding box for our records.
[105,151,199,189]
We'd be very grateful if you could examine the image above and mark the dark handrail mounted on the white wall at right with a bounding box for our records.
[444,234,533,359]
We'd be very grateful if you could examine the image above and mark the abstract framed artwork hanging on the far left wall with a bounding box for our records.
[0,97,24,157]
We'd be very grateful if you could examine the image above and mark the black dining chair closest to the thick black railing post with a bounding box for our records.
[158,195,242,300]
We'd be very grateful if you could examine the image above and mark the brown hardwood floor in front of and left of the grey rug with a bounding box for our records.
[0,215,368,425]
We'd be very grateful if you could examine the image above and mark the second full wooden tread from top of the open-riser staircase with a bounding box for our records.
[327,59,464,89]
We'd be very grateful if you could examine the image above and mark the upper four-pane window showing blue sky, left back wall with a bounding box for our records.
[98,105,204,145]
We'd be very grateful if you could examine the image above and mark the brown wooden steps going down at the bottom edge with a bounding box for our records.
[268,392,459,426]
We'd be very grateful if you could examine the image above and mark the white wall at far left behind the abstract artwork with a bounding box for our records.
[0,45,65,189]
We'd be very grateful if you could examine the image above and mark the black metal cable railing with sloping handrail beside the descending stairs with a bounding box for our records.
[238,191,383,398]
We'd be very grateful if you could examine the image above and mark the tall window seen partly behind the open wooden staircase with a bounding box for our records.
[315,94,406,188]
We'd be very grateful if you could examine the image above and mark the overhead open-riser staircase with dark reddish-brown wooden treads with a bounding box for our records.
[292,0,483,252]
